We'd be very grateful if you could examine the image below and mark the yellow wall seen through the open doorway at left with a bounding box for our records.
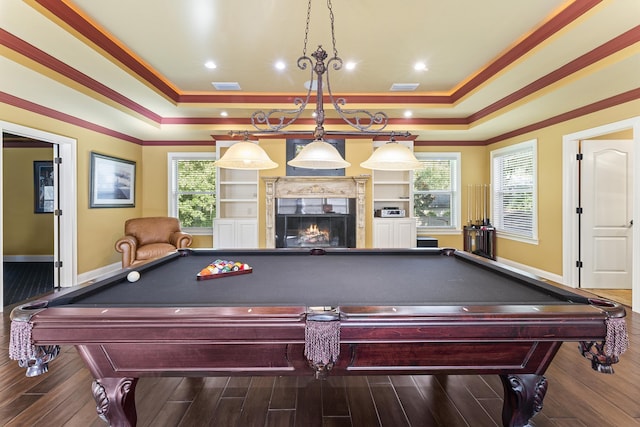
[2,148,54,256]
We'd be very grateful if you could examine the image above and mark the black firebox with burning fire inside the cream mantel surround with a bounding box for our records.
[275,198,356,248]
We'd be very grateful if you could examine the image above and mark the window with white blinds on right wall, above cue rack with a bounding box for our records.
[491,140,538,241]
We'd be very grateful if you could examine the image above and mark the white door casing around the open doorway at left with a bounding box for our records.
[0,121,77,311]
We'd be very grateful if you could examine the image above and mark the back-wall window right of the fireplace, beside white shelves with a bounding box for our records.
[413,153,460,230]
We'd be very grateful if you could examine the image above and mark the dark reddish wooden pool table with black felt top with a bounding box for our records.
[10,248,626,426]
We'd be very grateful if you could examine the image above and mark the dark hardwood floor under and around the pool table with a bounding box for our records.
[0,309,640,427]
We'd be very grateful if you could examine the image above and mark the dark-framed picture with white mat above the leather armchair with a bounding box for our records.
[89,152,136,208]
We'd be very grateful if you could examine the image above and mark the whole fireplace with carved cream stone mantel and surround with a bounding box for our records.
[262,175,369,248]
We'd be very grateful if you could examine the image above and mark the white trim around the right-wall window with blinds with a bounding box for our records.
[490,138,539,245]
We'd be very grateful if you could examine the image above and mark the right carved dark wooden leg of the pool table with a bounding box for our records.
[500,374,547,427]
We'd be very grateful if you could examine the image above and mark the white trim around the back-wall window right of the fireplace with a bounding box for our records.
[411,151,462,235]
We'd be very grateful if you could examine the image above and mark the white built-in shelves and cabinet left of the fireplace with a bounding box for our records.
[213,142,258,249]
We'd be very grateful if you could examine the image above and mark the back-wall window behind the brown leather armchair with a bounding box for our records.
[168,153,216,234]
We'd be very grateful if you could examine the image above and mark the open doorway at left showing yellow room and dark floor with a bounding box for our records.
[2,133,57,306]
